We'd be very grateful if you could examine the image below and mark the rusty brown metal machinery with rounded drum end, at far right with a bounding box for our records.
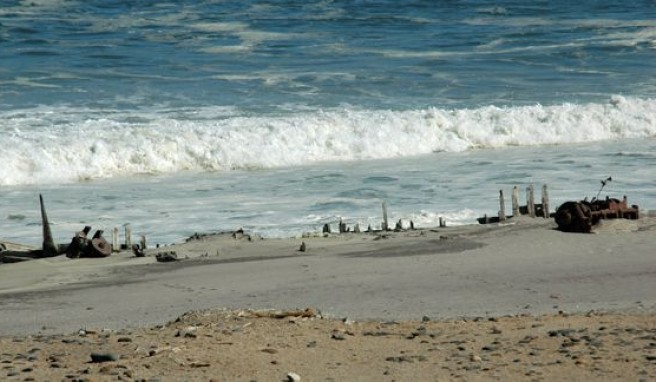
[555,196,640,233]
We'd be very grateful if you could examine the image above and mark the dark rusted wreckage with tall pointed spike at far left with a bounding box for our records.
[0,195,113,263]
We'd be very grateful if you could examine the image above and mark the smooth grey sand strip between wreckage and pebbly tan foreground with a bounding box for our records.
[0,216,656,333]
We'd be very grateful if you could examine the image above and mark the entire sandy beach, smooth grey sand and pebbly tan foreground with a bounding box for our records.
[0,217,656,381]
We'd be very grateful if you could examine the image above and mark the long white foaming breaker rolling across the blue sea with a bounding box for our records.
[0,96,656,186]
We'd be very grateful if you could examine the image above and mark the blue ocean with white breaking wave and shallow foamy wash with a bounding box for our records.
[0,0,656,245]
